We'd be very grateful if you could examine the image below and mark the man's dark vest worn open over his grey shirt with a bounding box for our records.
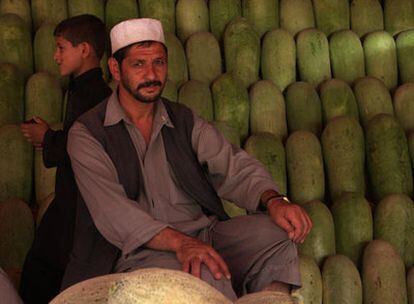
[62,99,228,289]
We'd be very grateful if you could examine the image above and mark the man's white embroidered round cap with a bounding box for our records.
[110,18,165,54]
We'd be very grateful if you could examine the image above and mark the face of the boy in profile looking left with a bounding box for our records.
[53,36,83,77]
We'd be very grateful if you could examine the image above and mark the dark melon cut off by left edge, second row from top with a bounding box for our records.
[0,14,33,79]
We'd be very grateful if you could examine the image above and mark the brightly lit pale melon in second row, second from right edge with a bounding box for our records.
[363,31,398,90]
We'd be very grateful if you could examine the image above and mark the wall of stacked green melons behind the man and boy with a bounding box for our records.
[0,0,414,303]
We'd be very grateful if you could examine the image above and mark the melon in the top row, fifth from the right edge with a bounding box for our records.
[242,0,279,37]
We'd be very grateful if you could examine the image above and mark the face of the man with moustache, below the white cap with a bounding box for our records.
[120,42,168,103]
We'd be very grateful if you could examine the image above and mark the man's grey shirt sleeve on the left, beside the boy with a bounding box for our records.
[68,122,169,254]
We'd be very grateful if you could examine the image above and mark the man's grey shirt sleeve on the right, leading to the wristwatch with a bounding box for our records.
[191,114,278,211]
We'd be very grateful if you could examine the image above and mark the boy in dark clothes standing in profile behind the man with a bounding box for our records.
[20,15,111,304]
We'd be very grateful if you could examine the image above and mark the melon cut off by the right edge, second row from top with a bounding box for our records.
[395,30,414,83]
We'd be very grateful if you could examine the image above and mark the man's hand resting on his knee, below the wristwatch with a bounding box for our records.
[267,199,312,243]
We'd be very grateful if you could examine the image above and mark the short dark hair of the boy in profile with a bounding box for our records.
[53,14,109,59]
